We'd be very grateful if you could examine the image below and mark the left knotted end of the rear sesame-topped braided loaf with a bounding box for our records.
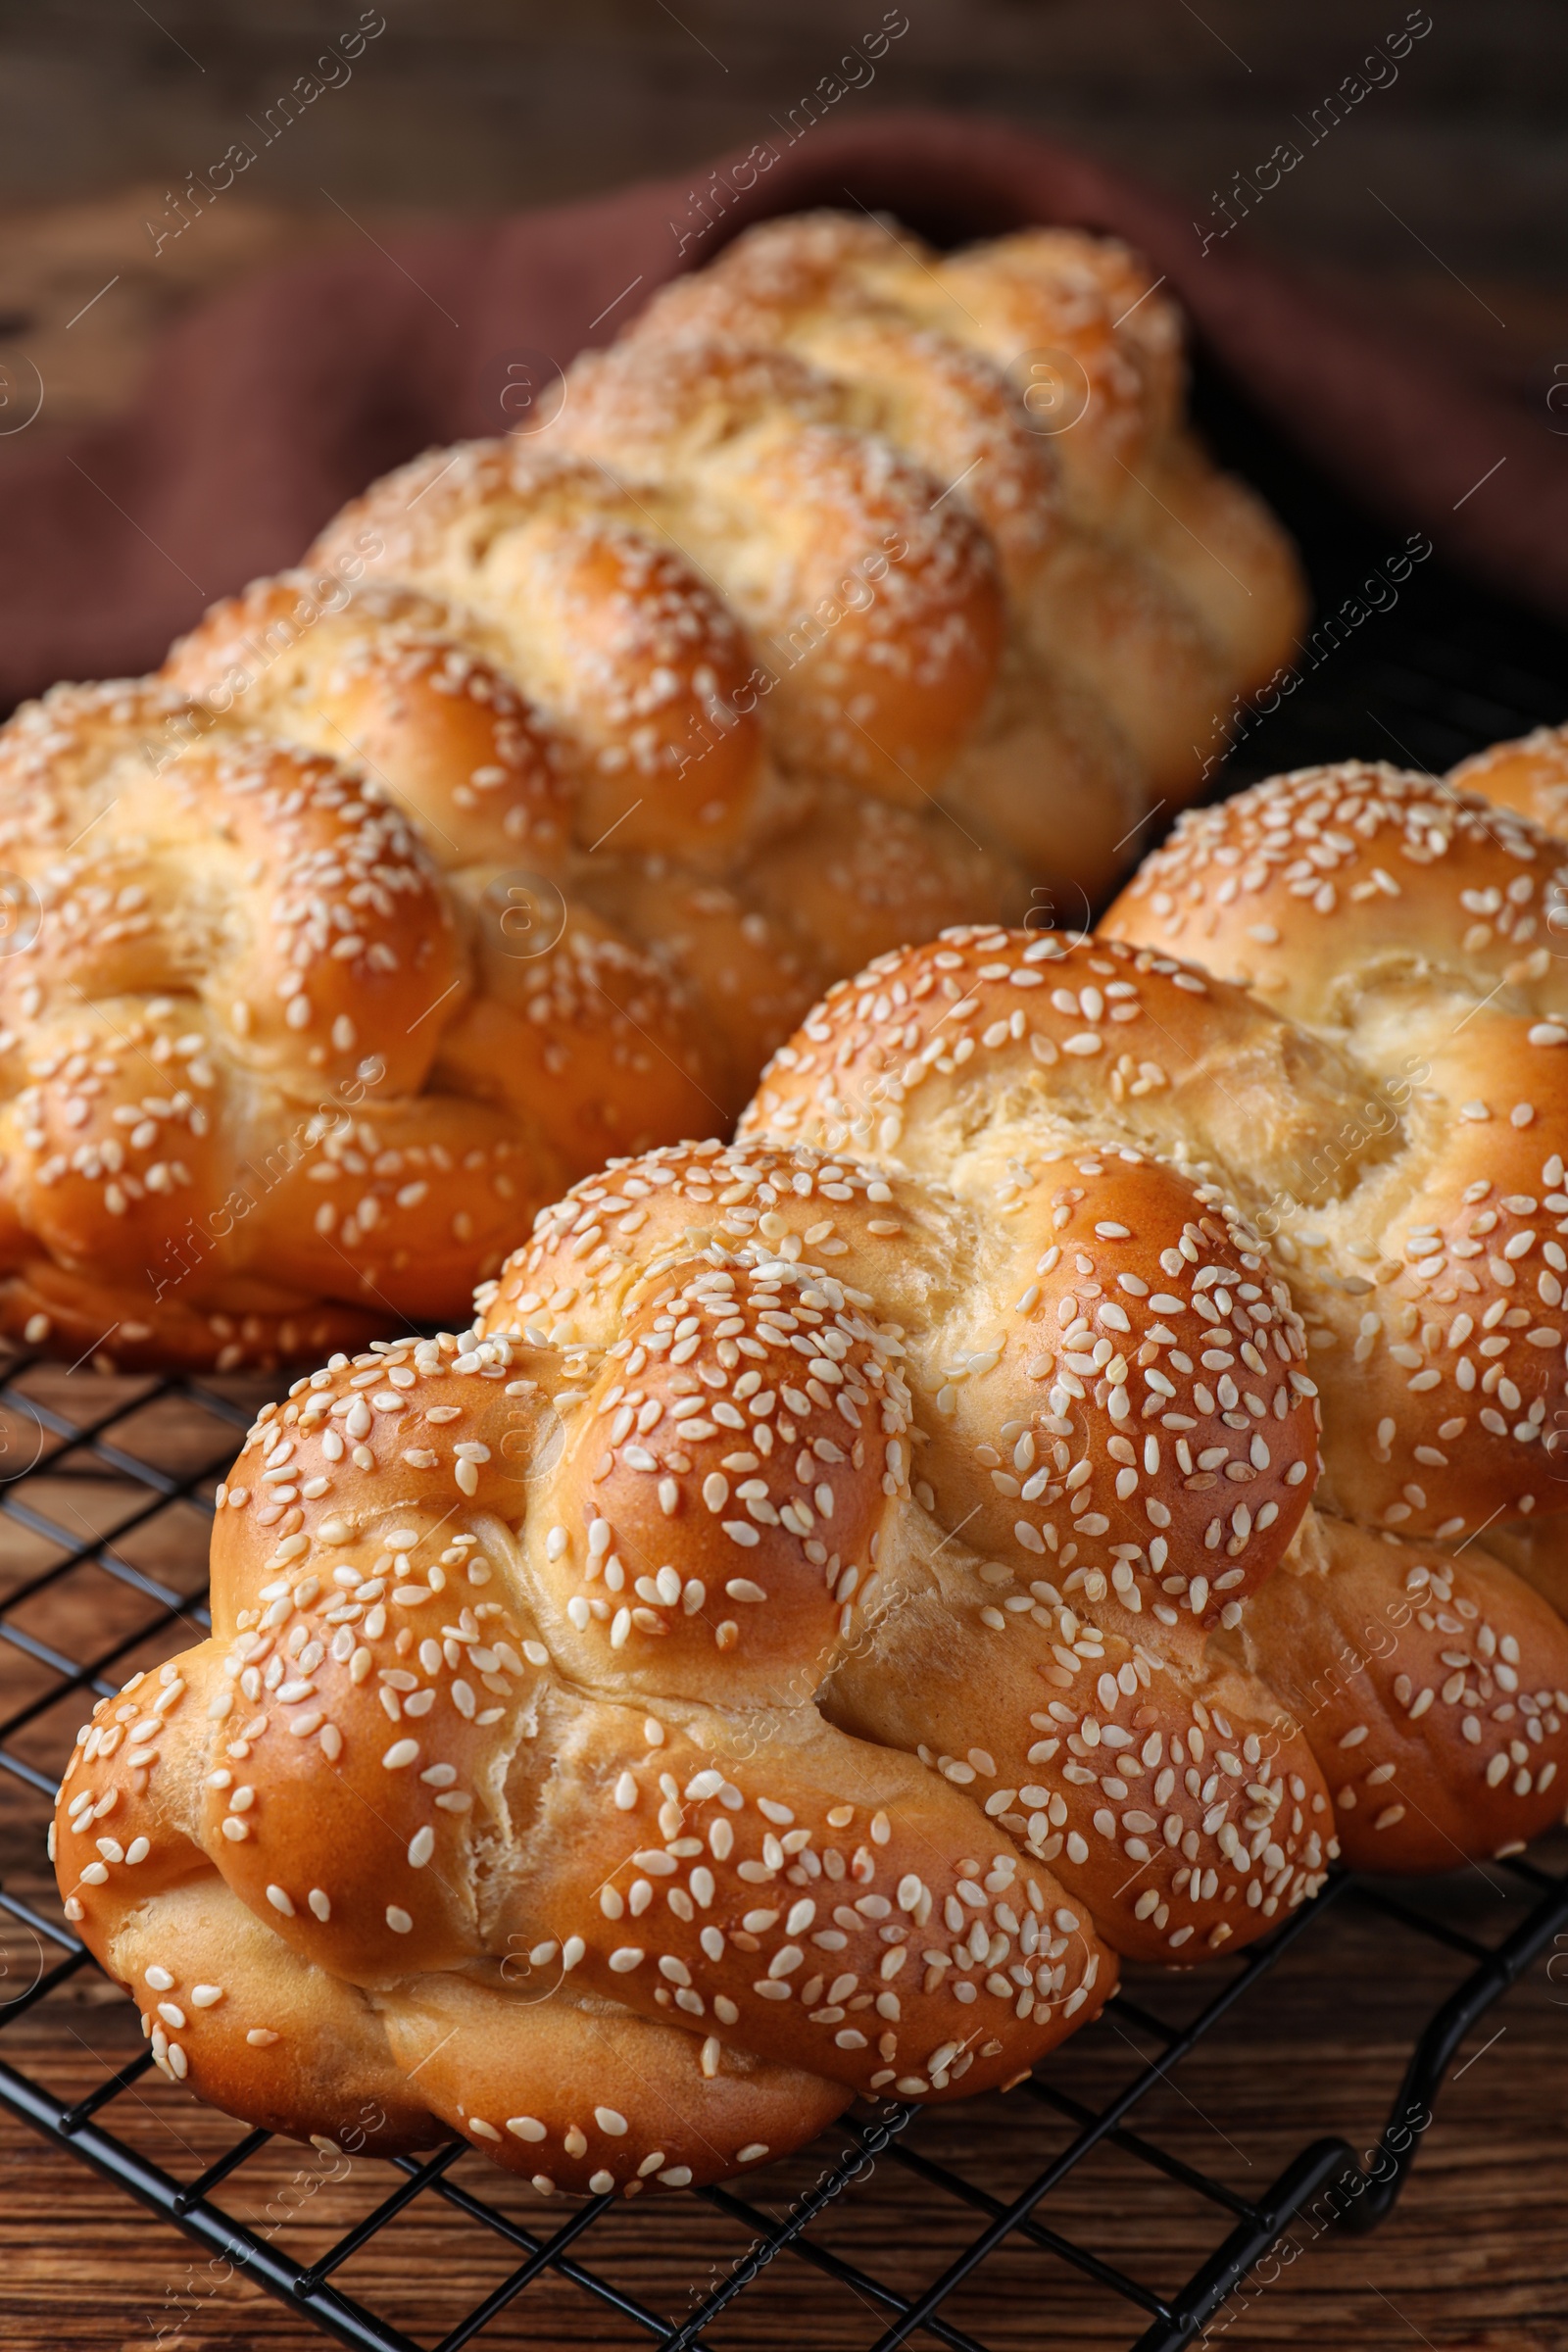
[0,684,566,1369]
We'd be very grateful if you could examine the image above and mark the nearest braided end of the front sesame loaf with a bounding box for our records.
[54,1289,1114,2194]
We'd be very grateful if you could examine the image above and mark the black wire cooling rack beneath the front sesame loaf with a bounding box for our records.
[0,1359,1568,2352]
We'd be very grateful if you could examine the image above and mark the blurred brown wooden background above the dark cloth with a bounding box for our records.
[0,0,1568,423]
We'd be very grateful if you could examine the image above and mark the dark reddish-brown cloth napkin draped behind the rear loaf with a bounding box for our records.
[0,113,1568,704]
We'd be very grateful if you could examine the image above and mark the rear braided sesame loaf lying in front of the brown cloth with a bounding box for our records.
[0,214,1300,1366]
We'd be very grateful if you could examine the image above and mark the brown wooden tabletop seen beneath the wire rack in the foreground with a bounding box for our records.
[0,1369,1568,2352]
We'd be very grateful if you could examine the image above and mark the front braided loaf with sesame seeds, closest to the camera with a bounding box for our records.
[57,743,1568,2189]
